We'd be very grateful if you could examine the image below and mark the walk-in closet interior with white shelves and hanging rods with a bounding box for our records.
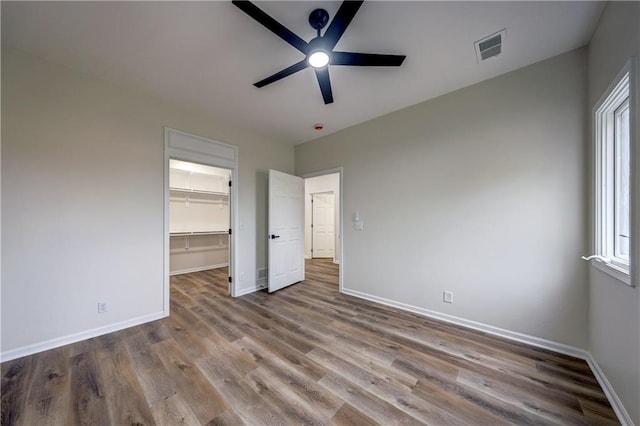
[169,160,230,275]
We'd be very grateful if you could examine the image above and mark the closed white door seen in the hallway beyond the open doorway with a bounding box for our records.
[311,192,335,258]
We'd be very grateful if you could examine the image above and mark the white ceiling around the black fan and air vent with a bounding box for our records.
[2,1,604,145]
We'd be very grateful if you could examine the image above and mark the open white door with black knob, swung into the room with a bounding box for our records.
[268,170,304,293]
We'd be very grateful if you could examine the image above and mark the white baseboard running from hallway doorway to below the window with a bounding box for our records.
[342,288,634,426]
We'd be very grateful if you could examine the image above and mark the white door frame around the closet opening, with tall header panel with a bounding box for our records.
[163,127,240,317]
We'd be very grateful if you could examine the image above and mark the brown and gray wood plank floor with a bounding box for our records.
[1,260,619,426]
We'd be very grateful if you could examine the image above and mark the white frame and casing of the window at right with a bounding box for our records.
[591,58,640,287]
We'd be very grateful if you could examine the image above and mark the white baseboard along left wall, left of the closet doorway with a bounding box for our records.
[0,312,167,362]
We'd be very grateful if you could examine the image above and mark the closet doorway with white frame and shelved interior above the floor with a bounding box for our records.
[163,127,238,317]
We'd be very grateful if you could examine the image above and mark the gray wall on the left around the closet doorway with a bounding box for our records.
[1,46,294,353]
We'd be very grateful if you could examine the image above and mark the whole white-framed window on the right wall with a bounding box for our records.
[594,64,634,284]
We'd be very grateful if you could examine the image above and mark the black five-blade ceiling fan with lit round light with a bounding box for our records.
[232,0,406,104]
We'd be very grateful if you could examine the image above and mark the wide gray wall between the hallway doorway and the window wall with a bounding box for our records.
[295,49,588,348]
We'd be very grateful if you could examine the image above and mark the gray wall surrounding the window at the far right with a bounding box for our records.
[588,2,640,425]
